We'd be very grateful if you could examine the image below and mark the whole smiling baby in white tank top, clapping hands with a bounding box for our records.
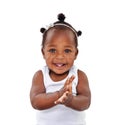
[30,13,91,125]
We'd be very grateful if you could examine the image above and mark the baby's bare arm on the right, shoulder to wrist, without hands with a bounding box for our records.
[65,70,91,111]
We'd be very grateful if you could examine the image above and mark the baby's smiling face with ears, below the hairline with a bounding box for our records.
[42,29,78,78]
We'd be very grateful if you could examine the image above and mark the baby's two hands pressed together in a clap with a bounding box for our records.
[55,76,75,104]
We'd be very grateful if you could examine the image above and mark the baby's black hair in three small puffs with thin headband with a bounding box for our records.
[40,13,82,47]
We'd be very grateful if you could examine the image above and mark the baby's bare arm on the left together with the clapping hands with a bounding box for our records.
[30,71,74,110]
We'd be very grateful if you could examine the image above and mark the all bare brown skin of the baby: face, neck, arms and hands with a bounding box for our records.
[30,29,91,111]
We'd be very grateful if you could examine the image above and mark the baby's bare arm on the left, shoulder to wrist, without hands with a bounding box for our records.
[30,71,59,110]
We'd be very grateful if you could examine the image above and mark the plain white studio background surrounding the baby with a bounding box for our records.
[0,0,120,125]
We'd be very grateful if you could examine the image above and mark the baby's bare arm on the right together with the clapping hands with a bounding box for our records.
[55,70,91,111]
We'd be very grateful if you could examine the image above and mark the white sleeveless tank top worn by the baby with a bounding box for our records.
[36,66,85,125]
